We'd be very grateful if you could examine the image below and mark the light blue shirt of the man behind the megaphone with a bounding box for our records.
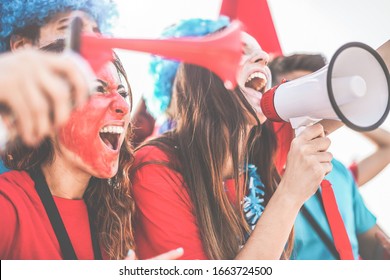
[291,160,376,260]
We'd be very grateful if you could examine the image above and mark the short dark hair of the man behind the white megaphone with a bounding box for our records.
[268,54,326,86]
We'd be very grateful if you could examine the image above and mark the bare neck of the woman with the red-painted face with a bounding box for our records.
[42,153,91,199]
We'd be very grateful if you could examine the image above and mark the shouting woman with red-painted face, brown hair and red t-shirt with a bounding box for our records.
[0,52,181,259]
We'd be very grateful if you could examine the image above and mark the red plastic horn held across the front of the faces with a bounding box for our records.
[70,18,242,89]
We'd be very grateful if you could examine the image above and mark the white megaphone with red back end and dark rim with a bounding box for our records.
[261,42,390,132]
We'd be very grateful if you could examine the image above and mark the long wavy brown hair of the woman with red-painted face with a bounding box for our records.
[2,55,134,259]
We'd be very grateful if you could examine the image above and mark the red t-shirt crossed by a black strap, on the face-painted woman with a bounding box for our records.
[0,171,94,260]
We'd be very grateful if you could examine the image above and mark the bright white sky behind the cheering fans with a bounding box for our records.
[113,0,390,234]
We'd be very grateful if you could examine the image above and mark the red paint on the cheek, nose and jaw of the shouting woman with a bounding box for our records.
[59,94,128,178]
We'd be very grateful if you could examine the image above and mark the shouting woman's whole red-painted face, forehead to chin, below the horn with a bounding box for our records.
[59,65,130,178]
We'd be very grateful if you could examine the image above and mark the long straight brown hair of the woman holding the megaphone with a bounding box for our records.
[136,64,292,259]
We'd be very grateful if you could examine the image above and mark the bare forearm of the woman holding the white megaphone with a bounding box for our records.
[236,184,302,260]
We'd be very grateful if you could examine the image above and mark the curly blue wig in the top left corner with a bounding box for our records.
[0,0,118,53]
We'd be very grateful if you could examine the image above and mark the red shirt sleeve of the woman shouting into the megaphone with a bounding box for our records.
[133,147,207,259]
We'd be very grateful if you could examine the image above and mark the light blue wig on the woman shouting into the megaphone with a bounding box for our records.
[144,16,229,118]
